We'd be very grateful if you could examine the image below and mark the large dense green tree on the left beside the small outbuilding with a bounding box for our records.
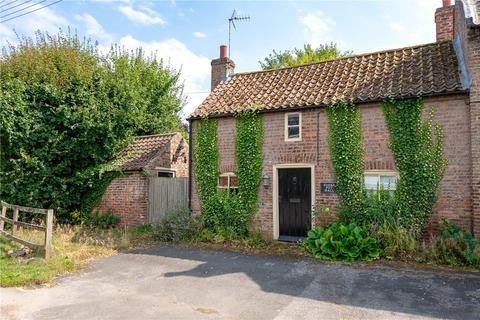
[0,32,184,219]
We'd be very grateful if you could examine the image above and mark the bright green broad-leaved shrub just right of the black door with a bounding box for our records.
[304,222,381,261]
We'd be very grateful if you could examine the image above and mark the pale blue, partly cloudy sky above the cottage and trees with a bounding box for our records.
[0,0,442,118]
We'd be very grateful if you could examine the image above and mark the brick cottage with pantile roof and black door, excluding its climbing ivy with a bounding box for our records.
[189,0,480,239]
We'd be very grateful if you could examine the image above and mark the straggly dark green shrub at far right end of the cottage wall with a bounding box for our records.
[424,221,480,268]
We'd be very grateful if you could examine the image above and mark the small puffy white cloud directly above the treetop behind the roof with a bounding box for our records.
[300,11,339,47]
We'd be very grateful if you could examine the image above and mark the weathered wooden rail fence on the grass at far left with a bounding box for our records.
[0,201,53,258]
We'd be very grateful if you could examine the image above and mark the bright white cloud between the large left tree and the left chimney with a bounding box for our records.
[119,35,210,116]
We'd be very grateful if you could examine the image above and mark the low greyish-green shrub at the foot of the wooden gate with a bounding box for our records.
[152,209,201,242]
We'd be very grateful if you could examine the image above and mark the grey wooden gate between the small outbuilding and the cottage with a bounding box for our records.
[148,177,188,223]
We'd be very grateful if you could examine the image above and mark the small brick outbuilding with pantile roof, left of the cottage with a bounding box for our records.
[95,133,188,226]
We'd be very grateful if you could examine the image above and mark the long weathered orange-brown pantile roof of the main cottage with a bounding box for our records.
[190,41,466,118]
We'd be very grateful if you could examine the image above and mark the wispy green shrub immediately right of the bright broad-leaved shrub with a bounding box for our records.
[374,222,418,260]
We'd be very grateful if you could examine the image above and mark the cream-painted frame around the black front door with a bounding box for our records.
[272,163,315,240]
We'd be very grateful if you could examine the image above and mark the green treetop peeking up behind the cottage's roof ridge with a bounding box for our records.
[258,43,352,70]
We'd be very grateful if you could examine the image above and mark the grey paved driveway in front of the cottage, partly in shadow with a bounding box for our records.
[0,247,480,320]
